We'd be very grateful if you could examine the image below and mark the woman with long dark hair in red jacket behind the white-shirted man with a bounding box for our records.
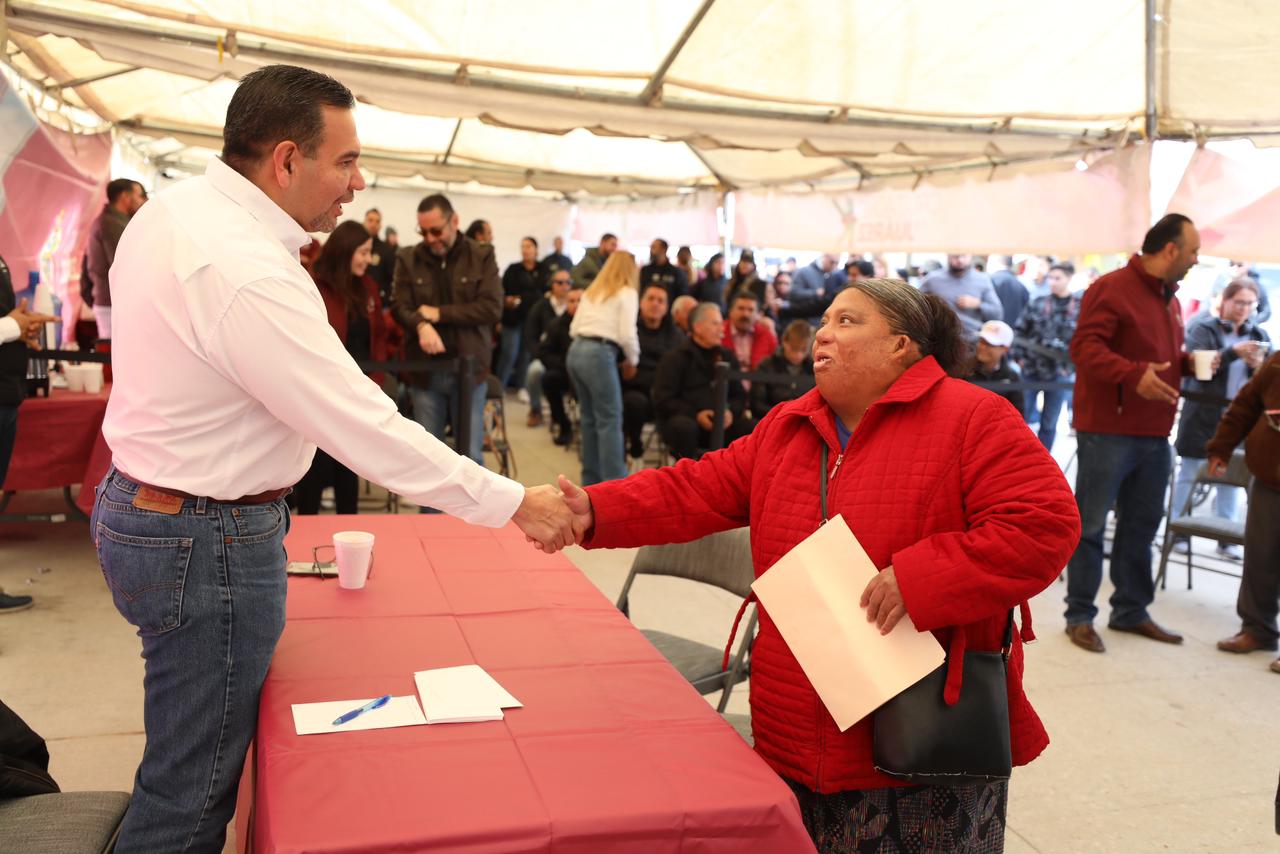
[296,222,387,516]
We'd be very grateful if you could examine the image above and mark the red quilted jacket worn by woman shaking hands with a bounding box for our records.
[585,357,1080,793]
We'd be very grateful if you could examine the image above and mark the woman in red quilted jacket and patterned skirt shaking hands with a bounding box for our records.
[561,279,1080,851]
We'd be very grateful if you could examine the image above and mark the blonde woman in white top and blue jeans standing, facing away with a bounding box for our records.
[566,251,640,484]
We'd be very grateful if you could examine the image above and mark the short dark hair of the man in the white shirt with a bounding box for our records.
[223,65,356,173]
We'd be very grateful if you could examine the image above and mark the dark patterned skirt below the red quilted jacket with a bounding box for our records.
[787,780,1009,854]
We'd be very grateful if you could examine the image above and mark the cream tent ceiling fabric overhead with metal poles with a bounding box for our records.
[4,0,1280,196]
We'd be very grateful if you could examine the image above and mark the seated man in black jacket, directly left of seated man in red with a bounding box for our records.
[653,302,751,460]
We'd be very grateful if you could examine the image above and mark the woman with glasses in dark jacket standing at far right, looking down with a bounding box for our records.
[1172,279,1271,561]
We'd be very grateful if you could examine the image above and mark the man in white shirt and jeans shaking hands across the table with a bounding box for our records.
[91,65,575,853]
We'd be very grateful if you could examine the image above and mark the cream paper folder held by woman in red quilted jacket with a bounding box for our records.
[751,516,946,731]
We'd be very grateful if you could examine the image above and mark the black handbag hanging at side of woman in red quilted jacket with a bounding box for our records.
[822,443,1014,786]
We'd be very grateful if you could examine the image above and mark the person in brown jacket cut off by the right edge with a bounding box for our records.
[1206,355,1280,673]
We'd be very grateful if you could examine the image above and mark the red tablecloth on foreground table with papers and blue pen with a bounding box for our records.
[239,516,813,854]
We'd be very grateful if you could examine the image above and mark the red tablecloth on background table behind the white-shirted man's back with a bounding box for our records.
[4,385,111,513]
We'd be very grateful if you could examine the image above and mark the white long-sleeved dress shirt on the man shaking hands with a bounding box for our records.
[102,157,524,528]
